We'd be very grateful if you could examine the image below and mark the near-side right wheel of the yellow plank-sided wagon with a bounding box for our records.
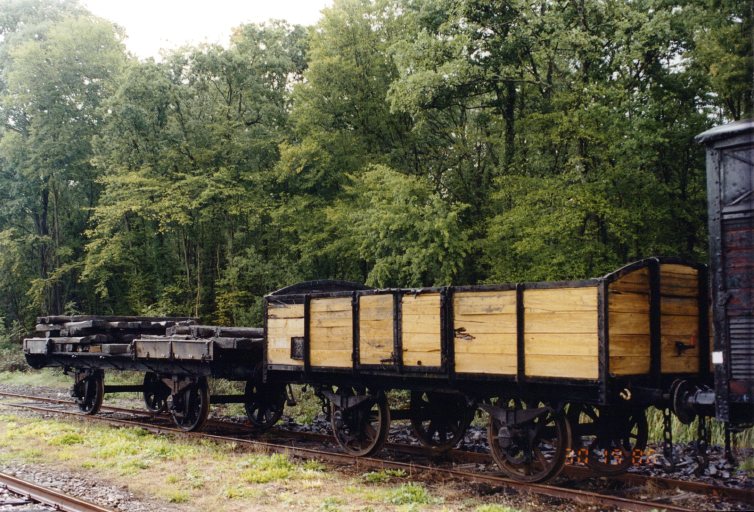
[487,399,571,482]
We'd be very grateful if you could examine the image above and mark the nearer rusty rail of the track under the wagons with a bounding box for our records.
[0,396,691,512]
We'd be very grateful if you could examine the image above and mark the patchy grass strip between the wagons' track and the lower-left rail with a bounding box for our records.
[0,406,524,512]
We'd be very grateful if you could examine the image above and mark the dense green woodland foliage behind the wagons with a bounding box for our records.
[0,0,754,328]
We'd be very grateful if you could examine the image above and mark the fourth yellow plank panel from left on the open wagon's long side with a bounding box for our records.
[401,293,441,366]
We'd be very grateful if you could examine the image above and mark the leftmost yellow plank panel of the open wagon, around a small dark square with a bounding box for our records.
[267,304,304,366]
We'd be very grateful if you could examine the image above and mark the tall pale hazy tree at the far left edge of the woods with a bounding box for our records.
[0,2,125,324]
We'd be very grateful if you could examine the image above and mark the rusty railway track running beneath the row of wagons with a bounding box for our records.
[0,392,754,512]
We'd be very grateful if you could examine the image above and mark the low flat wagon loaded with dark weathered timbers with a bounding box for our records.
[23,316,276,430]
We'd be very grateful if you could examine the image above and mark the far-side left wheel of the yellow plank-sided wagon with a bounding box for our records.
[410,391,474,450]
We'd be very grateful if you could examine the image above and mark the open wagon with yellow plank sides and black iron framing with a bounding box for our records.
[264,258,711,481]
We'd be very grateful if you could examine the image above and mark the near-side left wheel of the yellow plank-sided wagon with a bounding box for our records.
[331,387,390,457]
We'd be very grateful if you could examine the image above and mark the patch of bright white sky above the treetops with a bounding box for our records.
[82,0,332,59]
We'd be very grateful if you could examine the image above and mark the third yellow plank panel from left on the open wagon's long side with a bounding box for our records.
[359,294,393,364]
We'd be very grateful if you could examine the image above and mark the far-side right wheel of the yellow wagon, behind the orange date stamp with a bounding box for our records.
[567,404,649,475]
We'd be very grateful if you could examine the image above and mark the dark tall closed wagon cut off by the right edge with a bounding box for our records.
[696,119,754,428]
